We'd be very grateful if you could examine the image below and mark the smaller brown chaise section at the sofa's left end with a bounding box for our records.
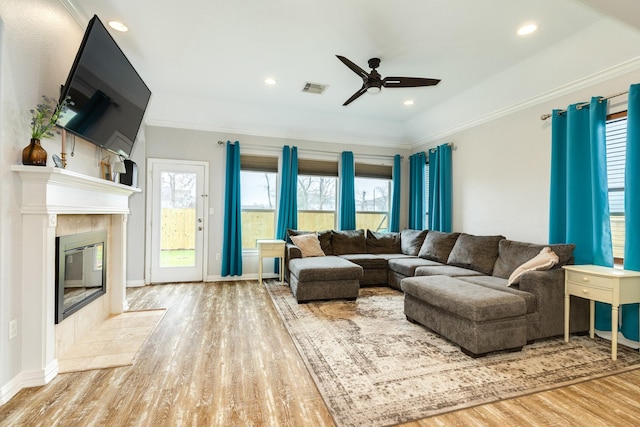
[289,256,363,302]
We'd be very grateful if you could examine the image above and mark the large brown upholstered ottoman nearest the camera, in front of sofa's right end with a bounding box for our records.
[401,276,527,357]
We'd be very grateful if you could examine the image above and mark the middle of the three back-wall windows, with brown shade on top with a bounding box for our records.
[297,159,338,231]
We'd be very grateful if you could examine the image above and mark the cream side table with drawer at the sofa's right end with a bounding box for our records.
[562,265,640,360]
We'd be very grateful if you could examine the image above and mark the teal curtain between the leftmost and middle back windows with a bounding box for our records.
[274,145,298,273]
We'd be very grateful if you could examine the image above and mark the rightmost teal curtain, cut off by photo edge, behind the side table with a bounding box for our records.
[620,84,640,341]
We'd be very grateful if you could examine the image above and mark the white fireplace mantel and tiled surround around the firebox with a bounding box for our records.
[12,166,140,387]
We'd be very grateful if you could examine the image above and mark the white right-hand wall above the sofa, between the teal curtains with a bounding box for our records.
[414,70,640,243]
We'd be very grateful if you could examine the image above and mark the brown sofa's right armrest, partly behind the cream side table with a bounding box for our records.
[519,268,589,338]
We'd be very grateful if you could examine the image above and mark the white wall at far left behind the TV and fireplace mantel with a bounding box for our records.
[0,0,105,404]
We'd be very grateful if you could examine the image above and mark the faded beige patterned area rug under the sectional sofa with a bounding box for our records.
[264,281,640,426]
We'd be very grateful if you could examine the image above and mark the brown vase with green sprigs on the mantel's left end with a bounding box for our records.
[22,95,73,166]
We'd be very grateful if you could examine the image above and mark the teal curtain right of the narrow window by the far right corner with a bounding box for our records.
[429,144,453,232]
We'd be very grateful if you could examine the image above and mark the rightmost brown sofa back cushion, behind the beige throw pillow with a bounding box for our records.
[493,239,576,279]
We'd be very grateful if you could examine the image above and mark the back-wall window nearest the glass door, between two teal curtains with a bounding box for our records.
[240,156,278,249]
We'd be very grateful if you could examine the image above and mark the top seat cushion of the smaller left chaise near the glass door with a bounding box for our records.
[289,256,362,282]
